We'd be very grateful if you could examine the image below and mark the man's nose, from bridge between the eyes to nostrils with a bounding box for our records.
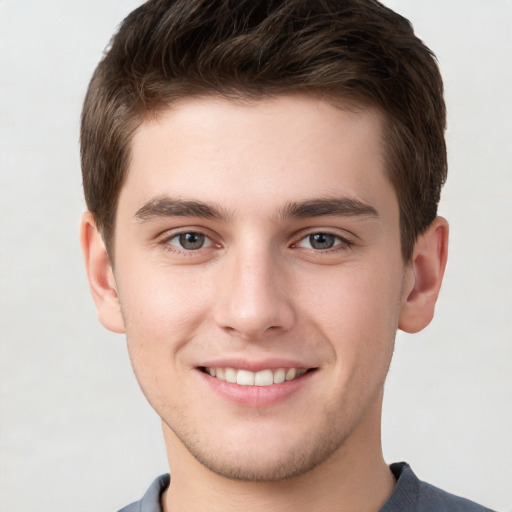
[215,245,295,340]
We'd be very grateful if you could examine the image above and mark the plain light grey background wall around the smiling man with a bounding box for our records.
[0,0,512,512]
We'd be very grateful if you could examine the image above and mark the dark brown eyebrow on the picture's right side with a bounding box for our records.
[281,197,379,219]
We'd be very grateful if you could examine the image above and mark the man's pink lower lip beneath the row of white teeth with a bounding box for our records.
[197,370,316,408]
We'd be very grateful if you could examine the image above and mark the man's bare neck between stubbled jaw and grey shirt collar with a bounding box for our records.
[162,400,396,512]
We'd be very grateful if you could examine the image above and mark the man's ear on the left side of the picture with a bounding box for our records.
[80,212,124,333]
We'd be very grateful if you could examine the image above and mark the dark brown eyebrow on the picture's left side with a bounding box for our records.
[135,196,228,221]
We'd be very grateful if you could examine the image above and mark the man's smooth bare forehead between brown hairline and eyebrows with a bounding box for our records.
[120,95,396,222]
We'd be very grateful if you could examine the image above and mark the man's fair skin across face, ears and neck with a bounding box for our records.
[82,96,448,511]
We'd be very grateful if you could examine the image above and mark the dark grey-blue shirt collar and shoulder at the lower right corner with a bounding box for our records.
[380,462,492,512]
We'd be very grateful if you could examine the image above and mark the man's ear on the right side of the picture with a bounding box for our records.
[398,217,448,333]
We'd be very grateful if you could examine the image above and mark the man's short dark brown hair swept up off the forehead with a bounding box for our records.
[81,0,447,261]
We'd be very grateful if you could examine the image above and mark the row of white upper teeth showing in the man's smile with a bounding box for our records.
[199,366,316,386]
